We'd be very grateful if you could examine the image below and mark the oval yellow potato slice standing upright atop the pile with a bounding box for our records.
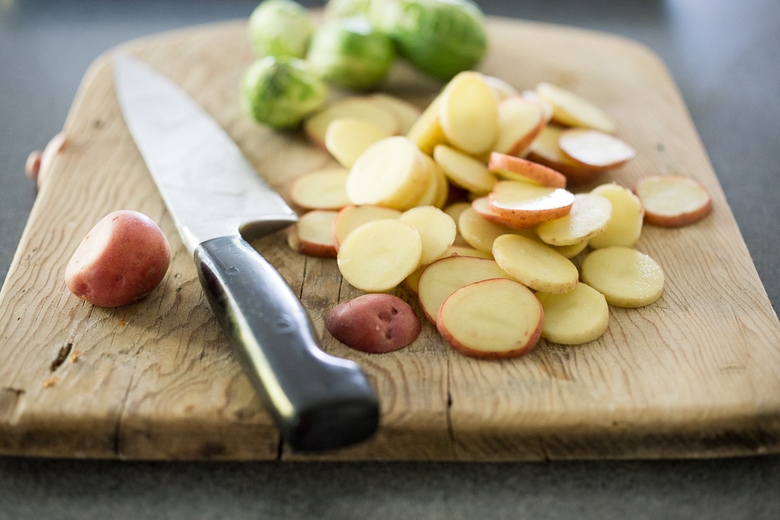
[439,71,498,155]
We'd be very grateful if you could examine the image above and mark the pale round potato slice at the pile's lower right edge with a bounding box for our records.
[582,246,664,308]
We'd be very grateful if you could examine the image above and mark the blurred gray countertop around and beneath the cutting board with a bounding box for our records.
[0,0,780,520]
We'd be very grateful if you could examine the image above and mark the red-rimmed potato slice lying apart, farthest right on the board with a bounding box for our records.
[634,175,712,227]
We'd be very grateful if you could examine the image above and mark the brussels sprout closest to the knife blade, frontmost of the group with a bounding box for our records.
[240,56,328,130]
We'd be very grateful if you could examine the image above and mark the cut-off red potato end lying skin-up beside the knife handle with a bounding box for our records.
[325,293,422,354]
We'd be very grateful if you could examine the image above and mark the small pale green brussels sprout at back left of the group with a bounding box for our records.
[247,0,315,58]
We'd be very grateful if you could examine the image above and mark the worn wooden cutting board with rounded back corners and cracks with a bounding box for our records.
[0,19,780,460]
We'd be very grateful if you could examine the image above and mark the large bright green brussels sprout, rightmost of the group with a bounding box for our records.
[370,0,488,81]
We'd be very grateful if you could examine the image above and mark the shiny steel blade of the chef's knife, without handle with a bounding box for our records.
[114,55,297,253]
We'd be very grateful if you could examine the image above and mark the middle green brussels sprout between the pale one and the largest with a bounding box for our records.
[306,16,396,90]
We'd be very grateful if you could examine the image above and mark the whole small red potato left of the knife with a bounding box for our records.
[65,210,171,307]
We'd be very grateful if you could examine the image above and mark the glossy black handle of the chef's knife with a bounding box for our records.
[194,236,379,451]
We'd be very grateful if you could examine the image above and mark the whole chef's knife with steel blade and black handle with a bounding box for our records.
[114,54,379,451]
